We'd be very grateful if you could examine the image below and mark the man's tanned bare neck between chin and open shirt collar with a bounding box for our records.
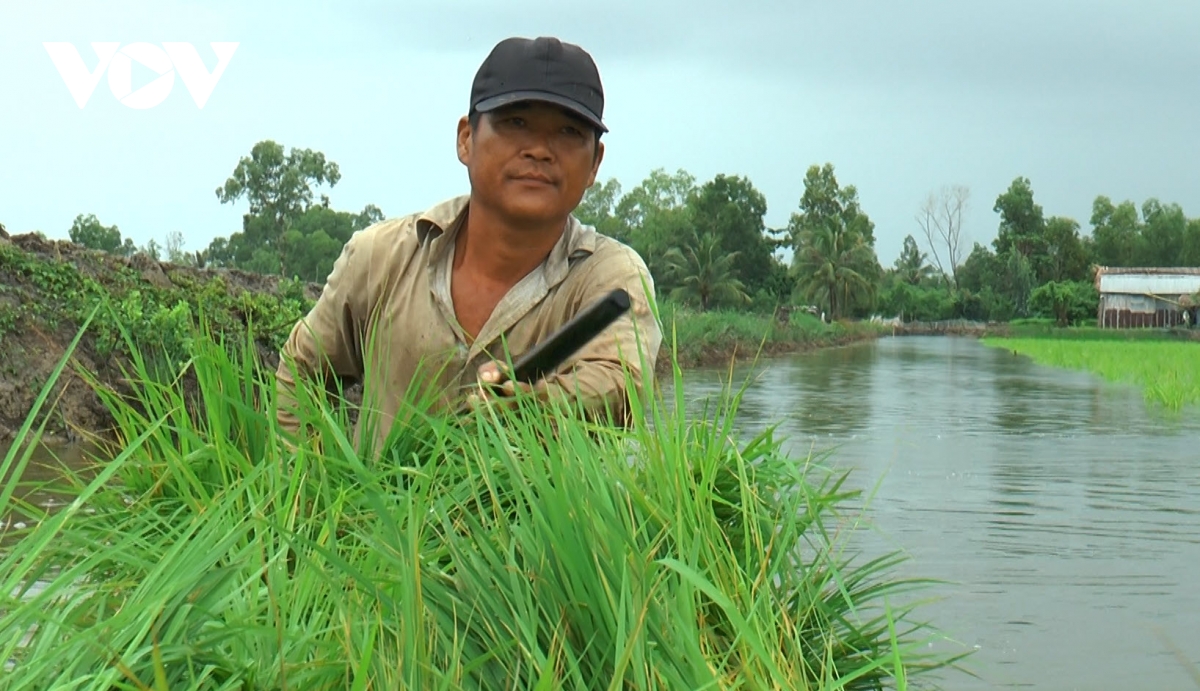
[454,199,566,287]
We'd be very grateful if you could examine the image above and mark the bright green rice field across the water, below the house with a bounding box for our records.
[984,330,1200,410]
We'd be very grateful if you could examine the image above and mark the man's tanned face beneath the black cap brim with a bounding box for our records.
[458,102,604,223]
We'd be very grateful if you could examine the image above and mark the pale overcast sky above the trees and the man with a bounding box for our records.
[0,0,1200,265]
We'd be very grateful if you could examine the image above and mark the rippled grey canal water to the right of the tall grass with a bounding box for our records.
[667,337,1200,691]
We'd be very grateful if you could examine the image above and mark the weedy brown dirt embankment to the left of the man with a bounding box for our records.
[0,226,322,443]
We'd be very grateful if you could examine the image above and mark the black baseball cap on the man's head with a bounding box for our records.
[470,37,608,132]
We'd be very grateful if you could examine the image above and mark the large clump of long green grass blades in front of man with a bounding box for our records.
[0,311,969,691]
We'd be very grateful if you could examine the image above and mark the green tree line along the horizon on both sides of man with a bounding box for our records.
[60,140,1200,324]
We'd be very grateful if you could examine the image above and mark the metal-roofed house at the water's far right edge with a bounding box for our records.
[1096,266,1200,329]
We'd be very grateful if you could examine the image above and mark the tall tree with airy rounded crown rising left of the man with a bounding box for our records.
[216,139,342,274]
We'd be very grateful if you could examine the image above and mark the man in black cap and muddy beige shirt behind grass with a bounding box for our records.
[276,38,662,453]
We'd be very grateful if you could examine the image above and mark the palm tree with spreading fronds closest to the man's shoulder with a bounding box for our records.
[662,233,750,311]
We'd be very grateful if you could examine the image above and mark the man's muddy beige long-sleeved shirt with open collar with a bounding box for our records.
[276,196,662,449]
